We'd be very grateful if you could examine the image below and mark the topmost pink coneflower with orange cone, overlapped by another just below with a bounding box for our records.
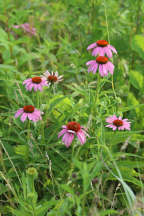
[87,40,117,58]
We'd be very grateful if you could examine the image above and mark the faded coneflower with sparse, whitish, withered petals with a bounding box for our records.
[42,71,63,84]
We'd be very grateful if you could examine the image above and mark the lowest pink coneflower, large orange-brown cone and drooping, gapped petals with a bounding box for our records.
[58,121,89,148]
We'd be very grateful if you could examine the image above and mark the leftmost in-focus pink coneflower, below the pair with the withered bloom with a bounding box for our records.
[15,105,42,122]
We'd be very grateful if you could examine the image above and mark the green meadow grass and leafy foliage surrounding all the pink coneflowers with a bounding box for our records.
[0,0,144,216]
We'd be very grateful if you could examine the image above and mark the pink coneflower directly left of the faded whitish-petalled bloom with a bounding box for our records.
[23,77,48,91]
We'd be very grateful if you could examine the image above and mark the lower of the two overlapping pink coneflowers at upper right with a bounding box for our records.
[86,56,114,77]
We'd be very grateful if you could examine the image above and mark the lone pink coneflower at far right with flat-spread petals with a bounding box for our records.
[106,115,131,130]
